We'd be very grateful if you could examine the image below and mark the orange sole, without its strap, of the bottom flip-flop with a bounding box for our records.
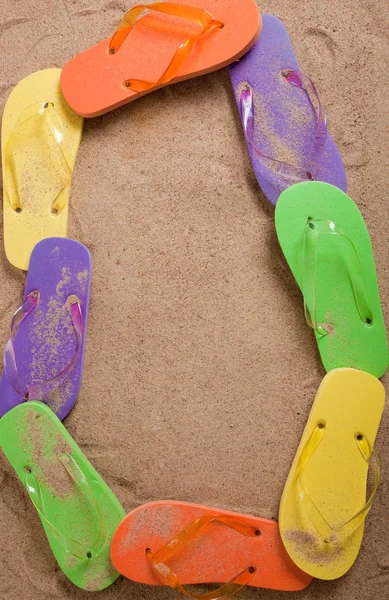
[111,501,312,590]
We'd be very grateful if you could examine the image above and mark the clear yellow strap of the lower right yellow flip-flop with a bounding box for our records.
[296,421,380,543]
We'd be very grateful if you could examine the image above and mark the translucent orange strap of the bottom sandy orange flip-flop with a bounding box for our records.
[146,515,261,600]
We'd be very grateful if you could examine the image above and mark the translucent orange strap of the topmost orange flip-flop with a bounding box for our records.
[109,2,224,92]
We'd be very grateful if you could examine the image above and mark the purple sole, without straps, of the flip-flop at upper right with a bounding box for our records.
[229,15,346,204]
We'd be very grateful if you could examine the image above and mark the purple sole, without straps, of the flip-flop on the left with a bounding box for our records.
[0,238,92,419]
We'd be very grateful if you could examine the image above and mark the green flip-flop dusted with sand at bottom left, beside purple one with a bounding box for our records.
[0,402,125,591]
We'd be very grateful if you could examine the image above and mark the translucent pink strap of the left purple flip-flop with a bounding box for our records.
[4,290,84,400]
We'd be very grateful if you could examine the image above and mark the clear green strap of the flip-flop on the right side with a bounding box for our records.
[302,219,373,336]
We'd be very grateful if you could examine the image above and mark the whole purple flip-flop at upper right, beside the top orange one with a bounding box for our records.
[230,15,346,204]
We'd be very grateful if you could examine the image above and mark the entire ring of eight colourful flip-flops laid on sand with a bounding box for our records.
[0,0,388,600]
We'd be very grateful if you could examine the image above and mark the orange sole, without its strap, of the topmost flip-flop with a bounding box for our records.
[61,0,261,117]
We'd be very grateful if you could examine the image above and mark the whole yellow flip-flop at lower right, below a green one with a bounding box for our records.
[279,369,385,579]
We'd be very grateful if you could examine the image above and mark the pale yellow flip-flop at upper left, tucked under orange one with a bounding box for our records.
[2,69,83,270]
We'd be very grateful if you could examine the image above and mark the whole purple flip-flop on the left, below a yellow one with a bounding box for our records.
[0,238,91,419]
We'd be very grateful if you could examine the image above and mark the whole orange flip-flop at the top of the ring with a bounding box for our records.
[61,0,261,117]
